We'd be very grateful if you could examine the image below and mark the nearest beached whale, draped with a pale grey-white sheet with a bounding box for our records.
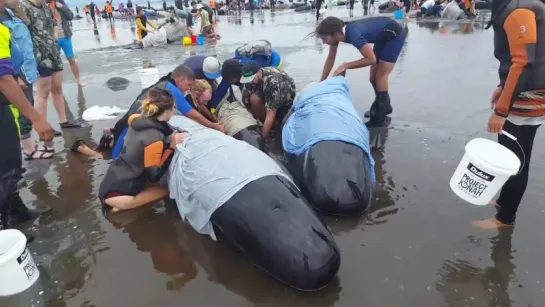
[169,116,340,291]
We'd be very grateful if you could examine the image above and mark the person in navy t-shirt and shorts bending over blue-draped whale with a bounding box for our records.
[314,17,407,126]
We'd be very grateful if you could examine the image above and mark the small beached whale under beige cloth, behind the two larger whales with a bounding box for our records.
[216,99,264,150]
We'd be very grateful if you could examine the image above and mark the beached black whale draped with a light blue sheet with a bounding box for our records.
[282,77,375,215]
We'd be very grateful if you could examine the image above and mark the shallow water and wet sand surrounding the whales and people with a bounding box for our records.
[0,8,545,307]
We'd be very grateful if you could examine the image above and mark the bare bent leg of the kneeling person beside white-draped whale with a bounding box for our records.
[104,185,168,212]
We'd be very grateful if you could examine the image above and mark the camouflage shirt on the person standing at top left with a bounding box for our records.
[19,0,62,70]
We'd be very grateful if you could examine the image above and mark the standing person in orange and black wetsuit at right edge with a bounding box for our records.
[475,0,545,228]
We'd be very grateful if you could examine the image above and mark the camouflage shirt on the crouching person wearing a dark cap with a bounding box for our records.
[247,67,295,111]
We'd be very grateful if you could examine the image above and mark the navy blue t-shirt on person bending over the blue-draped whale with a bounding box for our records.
[344,16,395,49]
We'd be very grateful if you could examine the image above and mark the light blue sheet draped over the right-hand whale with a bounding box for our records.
[282,77,375,183]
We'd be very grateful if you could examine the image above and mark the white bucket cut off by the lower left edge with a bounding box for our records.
[0,229,40,296]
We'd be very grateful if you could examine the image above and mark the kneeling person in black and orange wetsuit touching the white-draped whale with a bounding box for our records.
[98,88,186,212]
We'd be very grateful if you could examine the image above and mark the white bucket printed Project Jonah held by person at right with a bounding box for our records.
[450,138,520,206]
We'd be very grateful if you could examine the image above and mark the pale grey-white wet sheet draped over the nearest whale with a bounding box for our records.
[169,115,295,240]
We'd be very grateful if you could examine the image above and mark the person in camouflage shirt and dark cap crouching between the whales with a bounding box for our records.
[240,62,295,137]
